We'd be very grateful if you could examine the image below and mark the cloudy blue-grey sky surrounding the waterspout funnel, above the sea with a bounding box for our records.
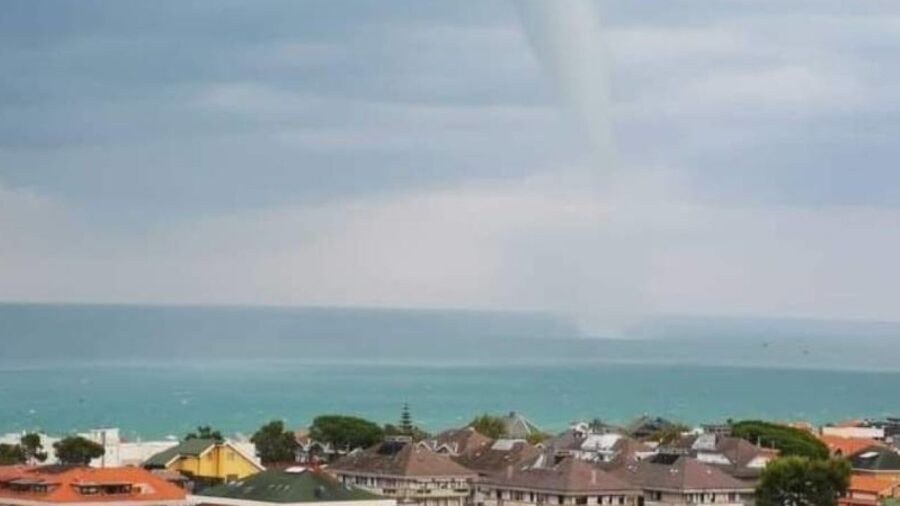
[0,0,900,325]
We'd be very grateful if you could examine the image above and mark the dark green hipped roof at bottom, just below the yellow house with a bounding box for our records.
[197,470,381,503]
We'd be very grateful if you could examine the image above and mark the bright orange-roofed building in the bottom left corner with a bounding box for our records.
[0,465,189,506]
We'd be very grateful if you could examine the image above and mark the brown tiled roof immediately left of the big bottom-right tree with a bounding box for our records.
[614,455,753,491]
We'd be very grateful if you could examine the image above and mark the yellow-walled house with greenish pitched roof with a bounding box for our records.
[144,439,264,482]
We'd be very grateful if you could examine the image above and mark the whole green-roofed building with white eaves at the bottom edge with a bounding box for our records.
[190,467,397,506]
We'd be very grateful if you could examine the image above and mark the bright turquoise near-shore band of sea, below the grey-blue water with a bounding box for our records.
[0,362,900,437]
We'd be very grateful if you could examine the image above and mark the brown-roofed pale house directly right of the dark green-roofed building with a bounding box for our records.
[328,437,477,506]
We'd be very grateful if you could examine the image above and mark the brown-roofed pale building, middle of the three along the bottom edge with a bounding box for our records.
[475,454,641,506]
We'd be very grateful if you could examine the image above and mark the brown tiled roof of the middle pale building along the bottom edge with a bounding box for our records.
[484,457,639,494]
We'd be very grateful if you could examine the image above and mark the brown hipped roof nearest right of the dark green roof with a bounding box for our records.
[329,441,475,477]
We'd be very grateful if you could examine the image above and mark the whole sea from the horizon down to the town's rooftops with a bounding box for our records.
[0,304,900,439]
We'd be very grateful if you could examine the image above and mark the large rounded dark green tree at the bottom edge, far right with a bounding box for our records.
[756,456,850,506]
